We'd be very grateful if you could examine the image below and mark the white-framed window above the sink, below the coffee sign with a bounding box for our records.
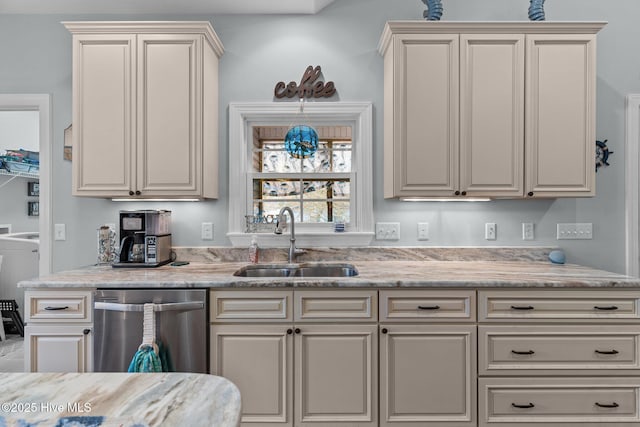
[228,102,373,247]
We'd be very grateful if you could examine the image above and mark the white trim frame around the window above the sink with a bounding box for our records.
[227,102,374,246]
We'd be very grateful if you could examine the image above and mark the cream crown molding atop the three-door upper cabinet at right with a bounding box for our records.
[378,20,607,55]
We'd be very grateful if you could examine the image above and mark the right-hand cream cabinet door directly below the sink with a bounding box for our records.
[294,324,378,427]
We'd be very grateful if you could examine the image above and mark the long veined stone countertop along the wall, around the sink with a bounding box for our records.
[18,260,640,289]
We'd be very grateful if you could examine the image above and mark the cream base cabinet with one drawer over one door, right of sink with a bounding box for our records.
[380,290,477,427]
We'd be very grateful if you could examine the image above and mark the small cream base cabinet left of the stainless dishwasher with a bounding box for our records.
[24,290,93,372]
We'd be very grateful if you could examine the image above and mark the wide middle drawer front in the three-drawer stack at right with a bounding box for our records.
[478,325,640,375]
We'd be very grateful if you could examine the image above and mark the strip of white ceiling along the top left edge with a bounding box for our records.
[0,0,334,15]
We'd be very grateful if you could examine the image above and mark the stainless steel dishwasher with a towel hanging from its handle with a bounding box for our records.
[93,289,208,373]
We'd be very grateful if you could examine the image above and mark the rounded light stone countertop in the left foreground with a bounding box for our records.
[0,373,241,427]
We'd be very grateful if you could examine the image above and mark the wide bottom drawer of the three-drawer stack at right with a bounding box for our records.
[478,378,640,427]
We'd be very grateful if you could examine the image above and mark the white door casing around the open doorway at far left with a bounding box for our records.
[0,94,53,275]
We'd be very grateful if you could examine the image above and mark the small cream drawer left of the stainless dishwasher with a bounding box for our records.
[25,291,93,323]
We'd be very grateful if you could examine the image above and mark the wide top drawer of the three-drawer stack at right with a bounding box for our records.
[478,289,640,322]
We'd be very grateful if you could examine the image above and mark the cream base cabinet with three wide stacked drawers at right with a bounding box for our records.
[478,289,640,427]
